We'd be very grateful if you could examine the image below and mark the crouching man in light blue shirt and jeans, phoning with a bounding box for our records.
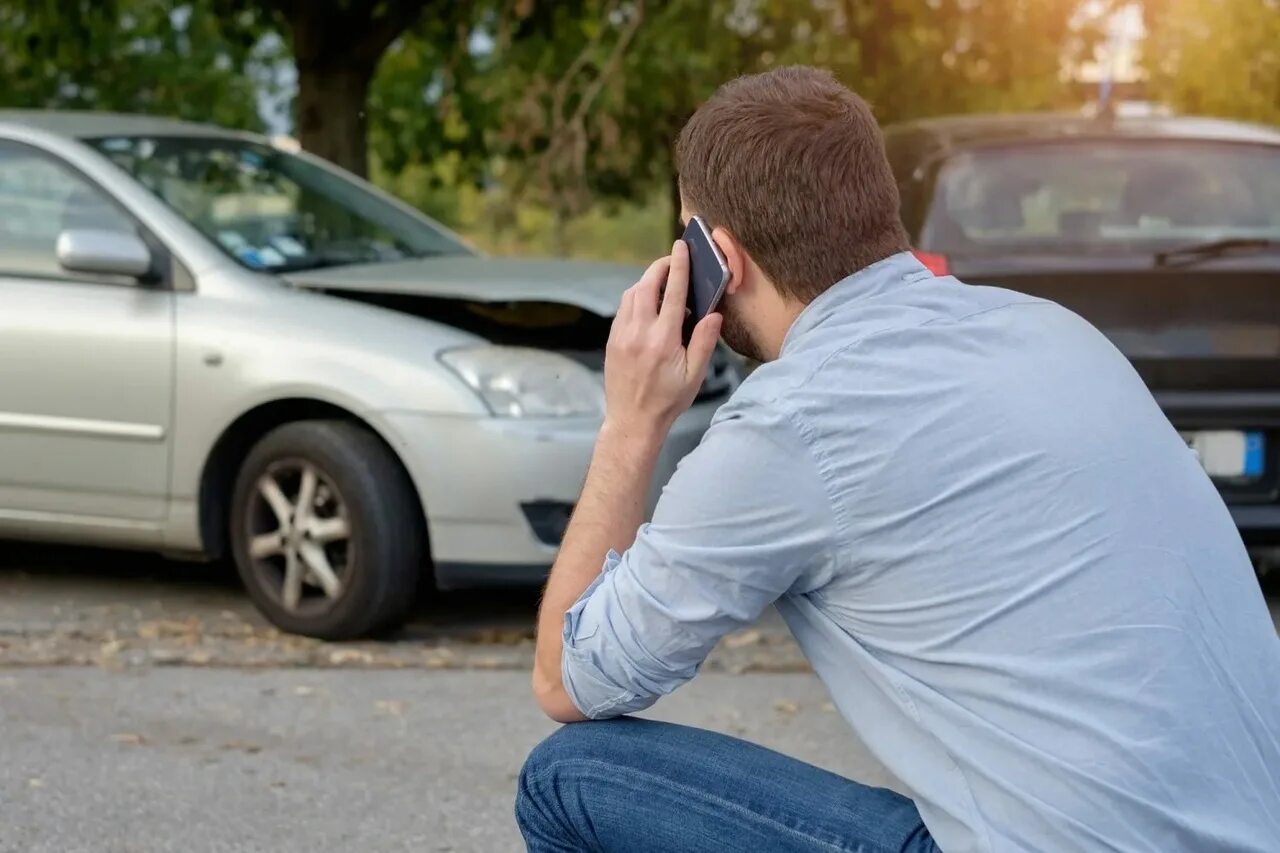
[516,68,1280,853]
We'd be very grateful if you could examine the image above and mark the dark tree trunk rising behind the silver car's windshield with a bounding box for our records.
[297,61,374,178]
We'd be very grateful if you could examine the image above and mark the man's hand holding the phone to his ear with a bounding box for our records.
[604,240,721,442]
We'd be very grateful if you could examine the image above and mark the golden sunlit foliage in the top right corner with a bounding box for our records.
[1143,0,1280,123]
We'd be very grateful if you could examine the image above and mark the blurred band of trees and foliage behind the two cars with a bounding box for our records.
[0,0,1264,261]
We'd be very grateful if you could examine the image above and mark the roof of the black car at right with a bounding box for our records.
[886,113,1280,149]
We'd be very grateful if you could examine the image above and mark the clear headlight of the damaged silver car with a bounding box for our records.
[440,346,604,418]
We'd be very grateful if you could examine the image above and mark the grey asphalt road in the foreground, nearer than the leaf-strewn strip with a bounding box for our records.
[0,667,887,853]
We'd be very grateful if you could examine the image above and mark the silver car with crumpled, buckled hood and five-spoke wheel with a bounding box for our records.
[0,111,737,630]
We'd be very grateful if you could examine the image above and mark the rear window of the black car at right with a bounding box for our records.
[920,141,1280,255]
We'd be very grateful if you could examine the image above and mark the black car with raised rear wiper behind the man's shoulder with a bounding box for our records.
[886,114,1280,567]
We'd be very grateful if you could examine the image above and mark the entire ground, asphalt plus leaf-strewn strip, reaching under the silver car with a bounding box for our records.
[0,542,1280,853]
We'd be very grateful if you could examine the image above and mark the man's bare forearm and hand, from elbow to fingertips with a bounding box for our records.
[532,241,721,722]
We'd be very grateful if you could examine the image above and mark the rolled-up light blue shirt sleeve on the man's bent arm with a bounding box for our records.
[561,407,836,719]
